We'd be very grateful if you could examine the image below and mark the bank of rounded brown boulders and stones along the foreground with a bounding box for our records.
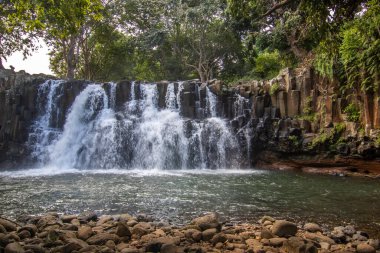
[0,212,380,253]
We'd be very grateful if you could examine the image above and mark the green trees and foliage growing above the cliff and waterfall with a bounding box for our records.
[0,0,380,91]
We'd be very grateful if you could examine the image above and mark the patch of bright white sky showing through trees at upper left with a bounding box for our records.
[4,41,53,75]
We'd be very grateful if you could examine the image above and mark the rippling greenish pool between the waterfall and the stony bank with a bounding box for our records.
[0,168,380,234]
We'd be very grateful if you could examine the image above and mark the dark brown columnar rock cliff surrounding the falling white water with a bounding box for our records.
[0,69,380,173]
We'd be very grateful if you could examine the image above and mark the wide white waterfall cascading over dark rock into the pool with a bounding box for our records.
[29,81,240,170]
